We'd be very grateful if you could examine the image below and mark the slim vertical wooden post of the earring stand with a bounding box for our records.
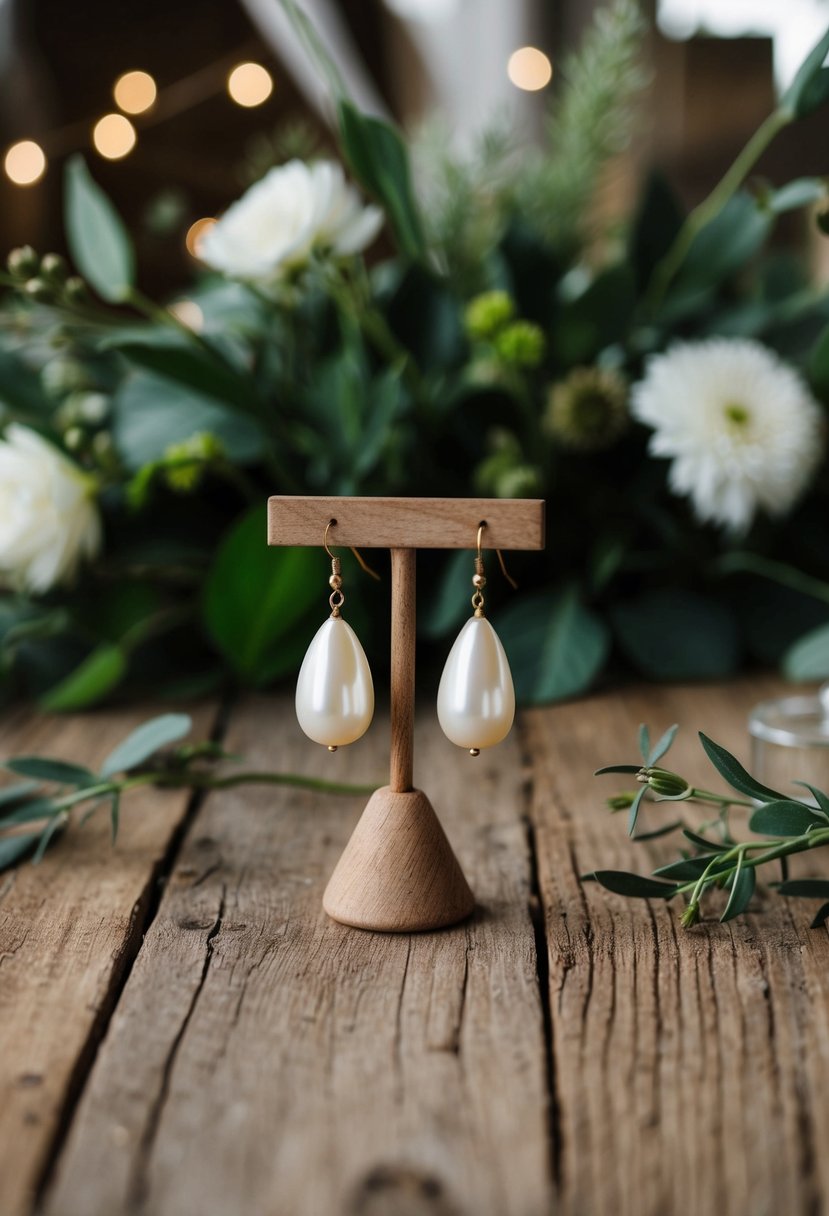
[389,548,417,794]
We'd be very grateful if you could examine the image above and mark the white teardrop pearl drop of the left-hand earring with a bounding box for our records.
[297,617,374,748]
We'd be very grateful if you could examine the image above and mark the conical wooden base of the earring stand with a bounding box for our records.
[322,786,475,933]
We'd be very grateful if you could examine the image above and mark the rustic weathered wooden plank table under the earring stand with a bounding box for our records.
[0,681,829,1216]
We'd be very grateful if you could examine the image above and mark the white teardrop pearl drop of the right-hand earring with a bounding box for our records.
[438,617,515,750]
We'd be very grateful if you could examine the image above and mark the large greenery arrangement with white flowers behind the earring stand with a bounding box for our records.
[0,0,829,710]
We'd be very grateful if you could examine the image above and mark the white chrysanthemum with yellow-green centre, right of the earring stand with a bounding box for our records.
[631,338,824,533]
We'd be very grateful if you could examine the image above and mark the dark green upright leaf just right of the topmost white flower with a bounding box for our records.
[338,101,427,260]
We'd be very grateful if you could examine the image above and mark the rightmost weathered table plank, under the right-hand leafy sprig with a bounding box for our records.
[524,681,829,1216]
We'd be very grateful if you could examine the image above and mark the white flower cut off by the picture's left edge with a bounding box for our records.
[0,423,101,595]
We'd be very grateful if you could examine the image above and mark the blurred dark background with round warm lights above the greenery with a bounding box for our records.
[0,0,829,294]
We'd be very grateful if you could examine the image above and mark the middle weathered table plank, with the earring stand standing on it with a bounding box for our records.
[46,700,552,1216]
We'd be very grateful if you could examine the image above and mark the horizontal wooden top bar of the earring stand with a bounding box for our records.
[267,495,545,550]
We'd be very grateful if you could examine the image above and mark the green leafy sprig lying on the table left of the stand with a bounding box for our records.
[0,714,374,871]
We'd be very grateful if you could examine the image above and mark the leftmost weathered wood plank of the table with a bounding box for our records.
[0,709,213,1216]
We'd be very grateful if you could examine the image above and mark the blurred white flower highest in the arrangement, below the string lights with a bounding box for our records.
[198,161,383,278]
